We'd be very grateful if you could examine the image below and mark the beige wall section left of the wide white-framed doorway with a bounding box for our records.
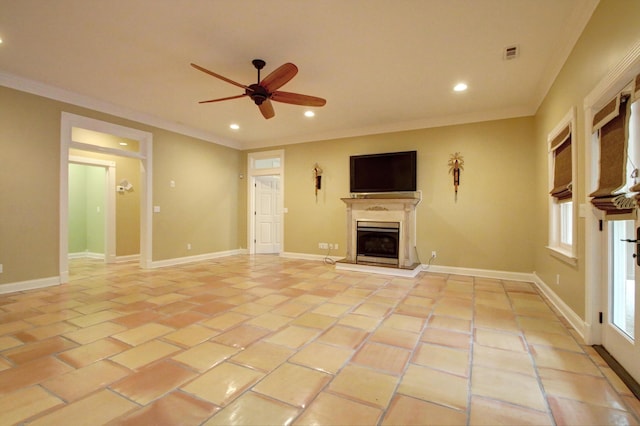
[0,87,60,283]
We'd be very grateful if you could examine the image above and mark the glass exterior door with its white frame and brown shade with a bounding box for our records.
[581,44,640,389]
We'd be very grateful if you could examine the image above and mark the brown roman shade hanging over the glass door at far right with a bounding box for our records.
[589,94,636,218]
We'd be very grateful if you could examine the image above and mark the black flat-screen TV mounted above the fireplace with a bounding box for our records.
[349,151,417,193]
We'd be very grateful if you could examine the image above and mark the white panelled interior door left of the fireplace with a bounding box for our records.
[255,176,282,254]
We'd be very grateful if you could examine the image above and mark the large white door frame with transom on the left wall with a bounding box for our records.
[59,112,153,283]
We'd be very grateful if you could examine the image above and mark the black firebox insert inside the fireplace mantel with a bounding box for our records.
[356,221,400,266]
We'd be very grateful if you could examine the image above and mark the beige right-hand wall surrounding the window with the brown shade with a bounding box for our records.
[533,0,640,319]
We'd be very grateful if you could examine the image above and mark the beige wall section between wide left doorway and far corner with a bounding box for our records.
[153,130,244,260]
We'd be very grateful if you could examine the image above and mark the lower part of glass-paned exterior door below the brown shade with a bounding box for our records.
[602,220,640,382]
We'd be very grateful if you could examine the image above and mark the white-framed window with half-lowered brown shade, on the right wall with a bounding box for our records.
[547,109,576,264]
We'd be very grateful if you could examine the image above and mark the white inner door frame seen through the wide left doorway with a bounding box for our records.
[67,155,116,263]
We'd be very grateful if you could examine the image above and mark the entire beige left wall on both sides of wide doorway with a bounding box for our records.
[0,87,241,285]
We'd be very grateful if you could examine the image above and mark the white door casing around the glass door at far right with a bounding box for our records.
[583,41,640,345]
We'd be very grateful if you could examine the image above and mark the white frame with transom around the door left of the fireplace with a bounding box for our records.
[247,149,286,254]
